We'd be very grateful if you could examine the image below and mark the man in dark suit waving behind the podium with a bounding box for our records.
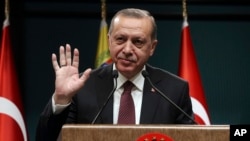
[36,8,193,141]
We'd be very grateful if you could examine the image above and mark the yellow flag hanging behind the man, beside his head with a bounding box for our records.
[95,19,112,68]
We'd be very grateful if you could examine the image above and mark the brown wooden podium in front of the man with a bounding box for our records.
[61,124,230,141]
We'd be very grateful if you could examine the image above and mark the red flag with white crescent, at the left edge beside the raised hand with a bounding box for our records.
[0,18,27,141]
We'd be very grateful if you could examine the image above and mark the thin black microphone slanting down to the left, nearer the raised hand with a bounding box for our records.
[91,70,118,124]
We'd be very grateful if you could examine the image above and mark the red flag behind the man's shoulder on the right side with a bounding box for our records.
[179,20,210,125]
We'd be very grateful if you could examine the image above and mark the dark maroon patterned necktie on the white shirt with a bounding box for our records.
[118,81,135,124]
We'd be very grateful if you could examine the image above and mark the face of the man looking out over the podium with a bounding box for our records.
[109,16,157,78]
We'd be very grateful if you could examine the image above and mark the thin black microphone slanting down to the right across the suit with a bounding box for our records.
[142,70,197,124]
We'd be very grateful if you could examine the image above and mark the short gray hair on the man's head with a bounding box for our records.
[108,8,157,39]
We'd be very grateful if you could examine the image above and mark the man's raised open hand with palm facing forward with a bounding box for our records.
[52,44,91,104]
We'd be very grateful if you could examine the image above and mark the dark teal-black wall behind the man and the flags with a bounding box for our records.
[0,0,250,140]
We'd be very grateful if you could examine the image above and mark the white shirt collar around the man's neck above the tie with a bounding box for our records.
[113,64,146,91]
